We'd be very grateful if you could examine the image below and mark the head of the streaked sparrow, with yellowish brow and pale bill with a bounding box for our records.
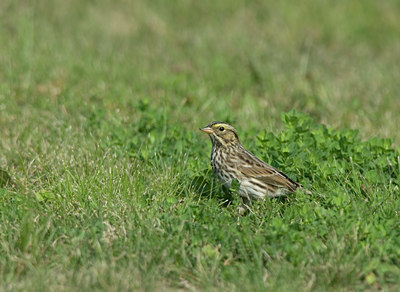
[200,122,240,147]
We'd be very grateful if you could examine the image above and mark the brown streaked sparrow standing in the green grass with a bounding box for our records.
[200,122,311,202]
